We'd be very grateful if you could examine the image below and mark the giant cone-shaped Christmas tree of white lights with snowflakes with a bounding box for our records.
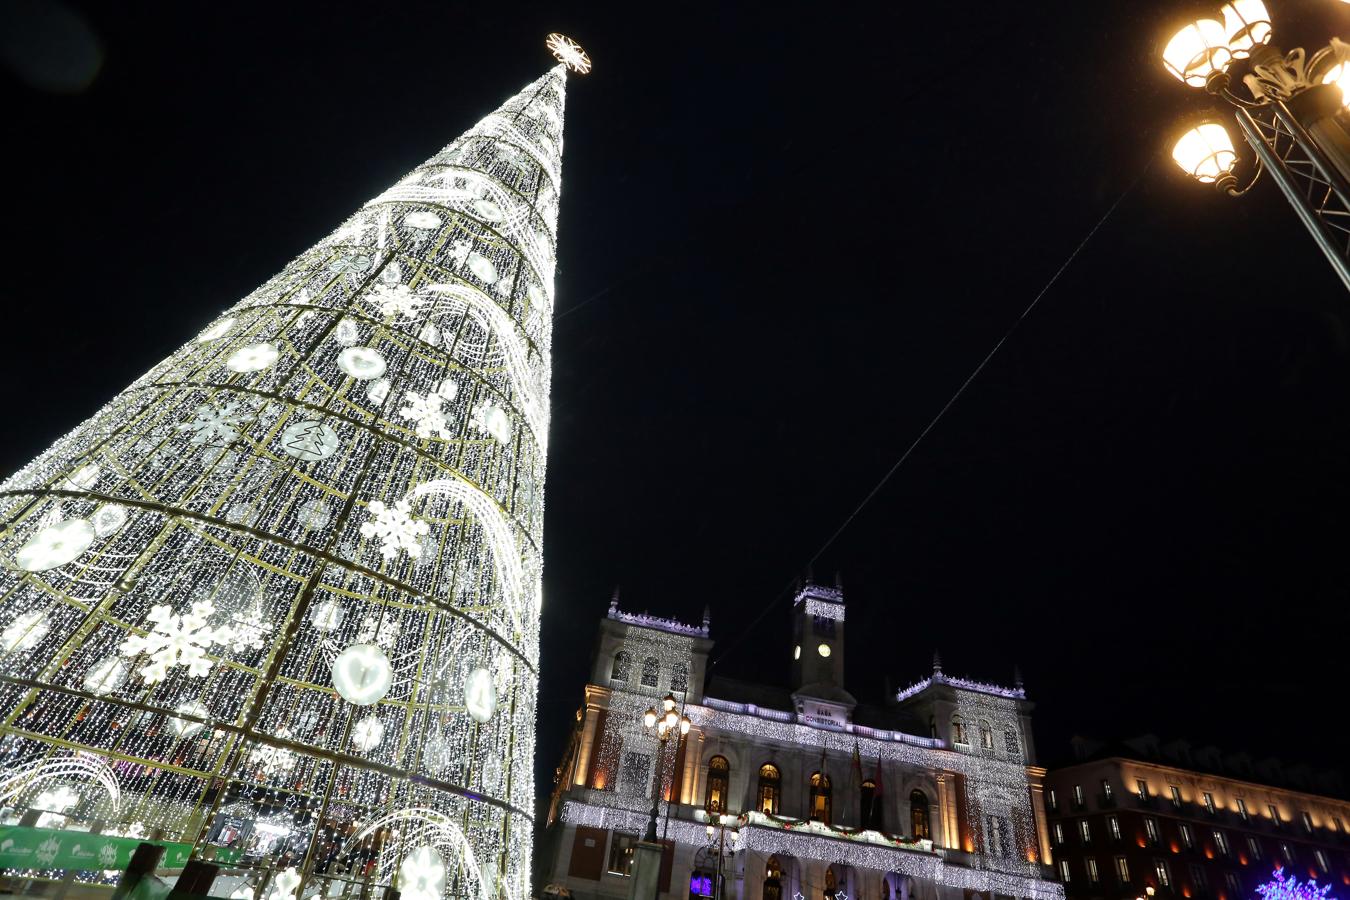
[0,35,589,897]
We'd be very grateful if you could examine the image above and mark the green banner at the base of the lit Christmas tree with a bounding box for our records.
[0,826,242,870]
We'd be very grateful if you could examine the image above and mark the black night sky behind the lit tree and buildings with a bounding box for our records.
[0,0,1350,814]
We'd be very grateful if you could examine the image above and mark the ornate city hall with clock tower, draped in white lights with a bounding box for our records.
[537,584,1064,900]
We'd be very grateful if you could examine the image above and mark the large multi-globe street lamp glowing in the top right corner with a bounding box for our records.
[1161,0,1350,289]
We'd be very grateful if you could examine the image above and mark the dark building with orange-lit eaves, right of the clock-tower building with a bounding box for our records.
[1045,735,1350,900]
